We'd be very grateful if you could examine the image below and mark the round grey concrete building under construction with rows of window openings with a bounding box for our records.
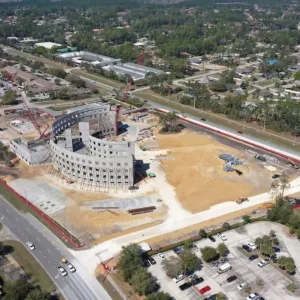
[11,104,134,189]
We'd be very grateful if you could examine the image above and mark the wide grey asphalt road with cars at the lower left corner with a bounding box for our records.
[0,196,111,300]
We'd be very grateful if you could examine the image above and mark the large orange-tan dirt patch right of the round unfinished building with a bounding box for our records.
[157,130,272,213]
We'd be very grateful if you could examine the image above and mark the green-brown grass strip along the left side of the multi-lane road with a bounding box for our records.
[4,240,56,293]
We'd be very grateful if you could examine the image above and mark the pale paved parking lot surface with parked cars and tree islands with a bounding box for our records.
[149,222,300,300]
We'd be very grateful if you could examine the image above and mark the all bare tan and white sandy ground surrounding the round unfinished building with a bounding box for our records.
[11,123,270,244]
